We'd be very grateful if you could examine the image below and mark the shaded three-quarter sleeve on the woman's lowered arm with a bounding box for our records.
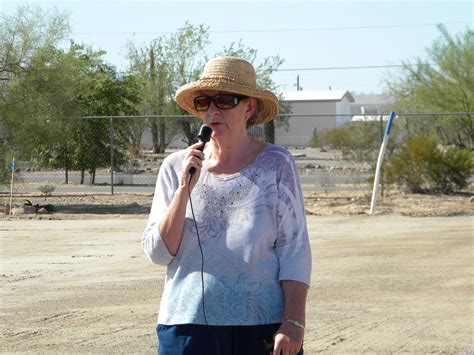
[275,155,311,286]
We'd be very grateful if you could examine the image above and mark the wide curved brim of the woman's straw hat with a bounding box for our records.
[175,78,280,125]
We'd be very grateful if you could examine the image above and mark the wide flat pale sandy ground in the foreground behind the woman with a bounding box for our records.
[0,216,474,354]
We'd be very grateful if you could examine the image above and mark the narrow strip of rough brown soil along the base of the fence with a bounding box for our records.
[0,190,474,220]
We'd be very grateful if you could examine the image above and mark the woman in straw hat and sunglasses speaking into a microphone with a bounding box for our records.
[143,57,311,355]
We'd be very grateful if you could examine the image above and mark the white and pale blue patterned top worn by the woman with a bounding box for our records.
[143,144,311,325]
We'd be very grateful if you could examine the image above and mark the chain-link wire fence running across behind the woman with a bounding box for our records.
[0,112,474,196]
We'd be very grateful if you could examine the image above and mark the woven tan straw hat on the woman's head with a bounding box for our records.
[175,57,279,125]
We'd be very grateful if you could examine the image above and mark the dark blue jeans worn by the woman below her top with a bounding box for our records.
[156,324,303,355]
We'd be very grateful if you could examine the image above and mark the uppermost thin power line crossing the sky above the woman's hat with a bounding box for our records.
[72,21,471,35]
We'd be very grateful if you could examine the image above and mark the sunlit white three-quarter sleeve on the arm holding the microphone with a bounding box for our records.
[142,156,177,265]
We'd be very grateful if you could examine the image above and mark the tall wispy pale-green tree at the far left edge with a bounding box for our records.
[0,6,70,177]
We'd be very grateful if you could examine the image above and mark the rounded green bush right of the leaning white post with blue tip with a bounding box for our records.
[386,135,473,193]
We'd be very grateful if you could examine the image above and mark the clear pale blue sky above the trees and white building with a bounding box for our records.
[0,0,474,93]
